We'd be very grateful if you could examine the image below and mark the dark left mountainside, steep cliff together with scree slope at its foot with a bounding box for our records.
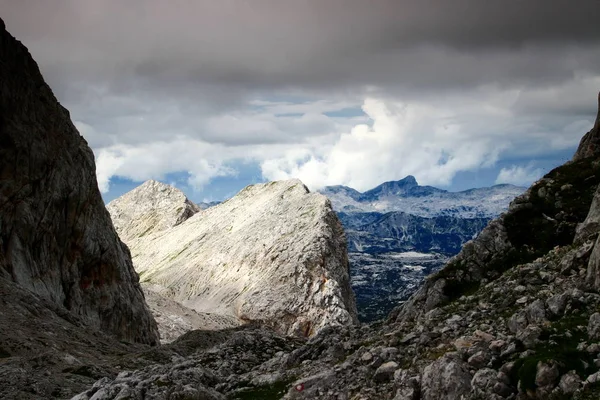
[0,20,158,399]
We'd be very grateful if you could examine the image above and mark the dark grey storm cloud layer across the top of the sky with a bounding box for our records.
[0,0,600,96]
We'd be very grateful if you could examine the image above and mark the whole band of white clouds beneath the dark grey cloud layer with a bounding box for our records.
[83,87,591,192]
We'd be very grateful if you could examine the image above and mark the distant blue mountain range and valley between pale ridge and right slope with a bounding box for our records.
[320,176,525,321]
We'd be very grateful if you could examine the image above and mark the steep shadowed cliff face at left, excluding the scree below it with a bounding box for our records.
[0,17,158,343]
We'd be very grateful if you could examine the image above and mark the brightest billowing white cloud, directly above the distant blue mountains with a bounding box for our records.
[261,95,552,190]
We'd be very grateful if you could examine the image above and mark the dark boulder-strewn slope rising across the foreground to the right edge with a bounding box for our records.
[78,91,600,400]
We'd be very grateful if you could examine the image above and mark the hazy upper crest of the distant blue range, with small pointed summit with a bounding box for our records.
[320,176,525,218]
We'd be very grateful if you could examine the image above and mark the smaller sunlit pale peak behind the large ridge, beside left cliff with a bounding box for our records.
[106,180,201,242]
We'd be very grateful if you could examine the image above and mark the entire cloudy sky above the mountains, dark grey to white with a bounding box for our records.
[0,0,600,201]
